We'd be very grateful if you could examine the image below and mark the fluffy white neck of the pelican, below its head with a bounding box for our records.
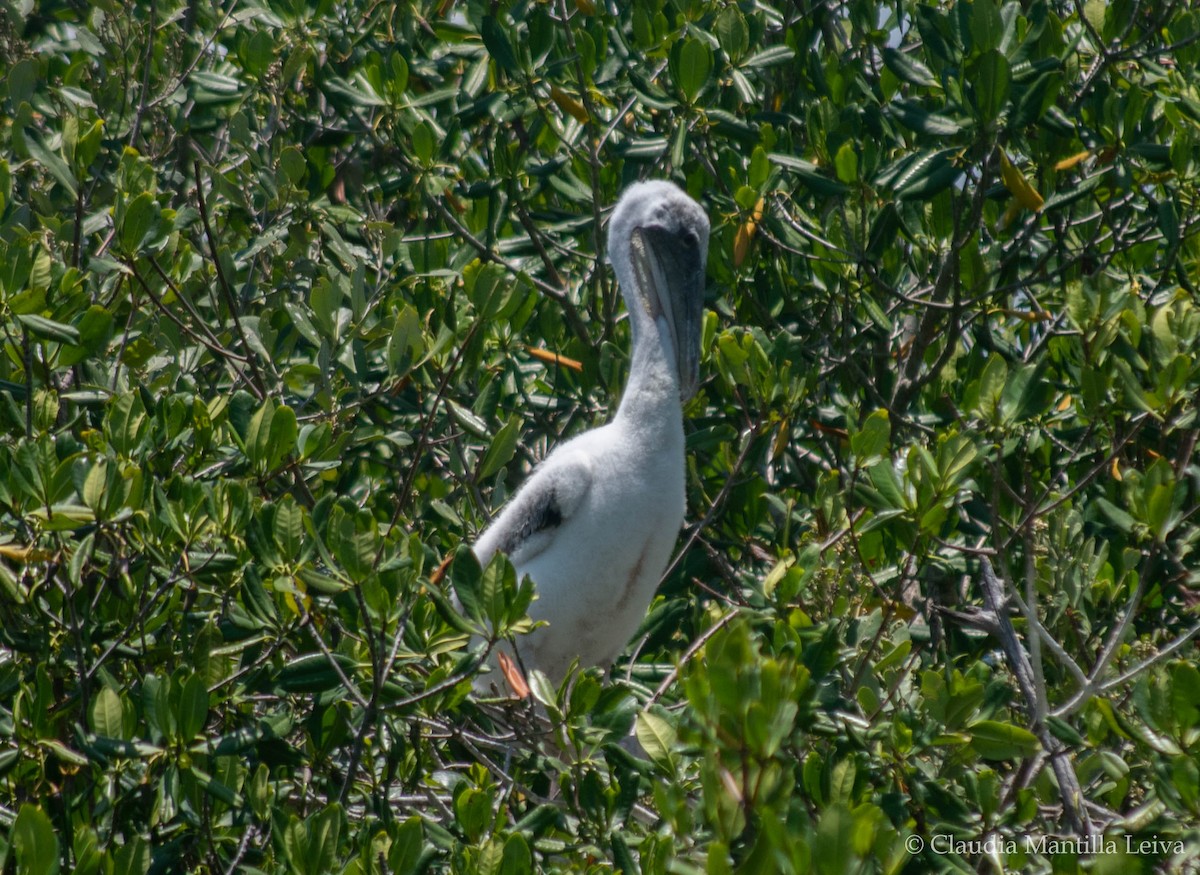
[616,302,683,441]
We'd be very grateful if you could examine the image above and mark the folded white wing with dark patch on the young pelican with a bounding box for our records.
[474,453,592,568]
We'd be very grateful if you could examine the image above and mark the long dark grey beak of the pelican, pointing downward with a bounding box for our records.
[630,227,708,401]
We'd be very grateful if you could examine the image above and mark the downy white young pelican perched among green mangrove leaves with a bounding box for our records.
[474,181,708,683]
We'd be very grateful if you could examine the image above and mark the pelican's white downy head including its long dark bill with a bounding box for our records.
[608,181,708,401]
